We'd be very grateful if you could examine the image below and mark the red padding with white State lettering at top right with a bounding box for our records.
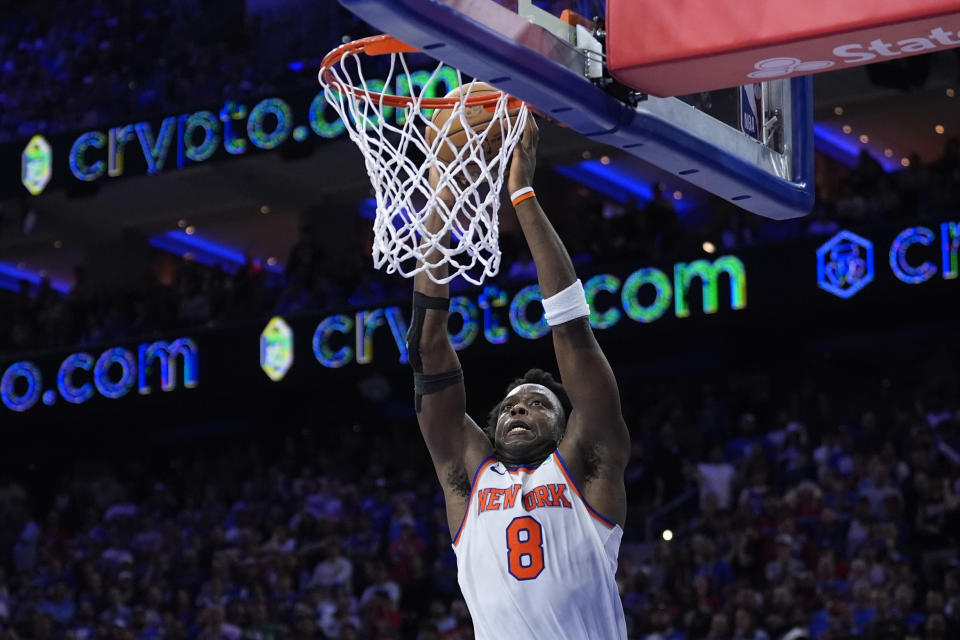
[606,0,960,96]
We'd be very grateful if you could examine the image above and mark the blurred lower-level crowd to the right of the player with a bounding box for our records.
[621,375,960,640]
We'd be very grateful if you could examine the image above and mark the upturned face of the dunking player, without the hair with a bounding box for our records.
[496,383,564,459]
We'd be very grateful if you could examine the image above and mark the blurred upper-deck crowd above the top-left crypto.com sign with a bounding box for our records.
[0,0,365,143]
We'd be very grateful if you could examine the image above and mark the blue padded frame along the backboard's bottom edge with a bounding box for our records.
[339,0,814,220]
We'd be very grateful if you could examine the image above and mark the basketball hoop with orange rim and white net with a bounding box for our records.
[319,35,527,285]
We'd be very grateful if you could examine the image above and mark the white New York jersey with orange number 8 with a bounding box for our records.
[453,451,627,640]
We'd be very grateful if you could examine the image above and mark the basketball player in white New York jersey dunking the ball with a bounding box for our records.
[407,117,630,640]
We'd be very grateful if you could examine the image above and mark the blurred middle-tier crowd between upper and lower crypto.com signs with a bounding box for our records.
[0,138,960,354]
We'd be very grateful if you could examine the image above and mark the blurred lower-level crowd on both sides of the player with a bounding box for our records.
[0,352,960,640]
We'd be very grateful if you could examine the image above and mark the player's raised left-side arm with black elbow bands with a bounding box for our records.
[407,168,493,533]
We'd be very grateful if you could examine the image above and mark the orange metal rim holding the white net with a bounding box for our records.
[320,33,523,111]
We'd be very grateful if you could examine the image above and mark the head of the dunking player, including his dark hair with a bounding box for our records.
[486,369,573,464]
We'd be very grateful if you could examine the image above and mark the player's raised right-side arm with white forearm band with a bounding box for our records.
[508,118,630,525]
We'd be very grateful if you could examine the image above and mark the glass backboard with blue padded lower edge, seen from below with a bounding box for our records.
[339,0,813,219]
